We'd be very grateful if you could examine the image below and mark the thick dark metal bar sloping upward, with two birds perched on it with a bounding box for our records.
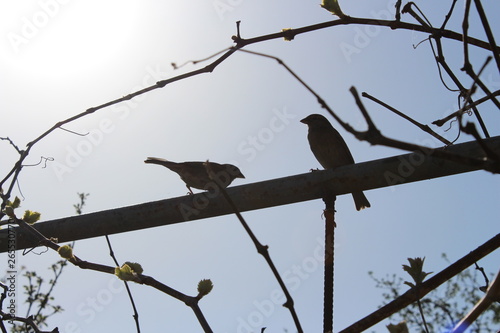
[0,137,500,252]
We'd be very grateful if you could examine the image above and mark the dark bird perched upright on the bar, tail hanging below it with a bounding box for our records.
[300,114,370,210]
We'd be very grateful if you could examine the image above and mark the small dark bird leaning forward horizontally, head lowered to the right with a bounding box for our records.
[144,157,245,194]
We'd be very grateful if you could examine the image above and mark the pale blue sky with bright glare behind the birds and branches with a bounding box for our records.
[0,0,500,333]
